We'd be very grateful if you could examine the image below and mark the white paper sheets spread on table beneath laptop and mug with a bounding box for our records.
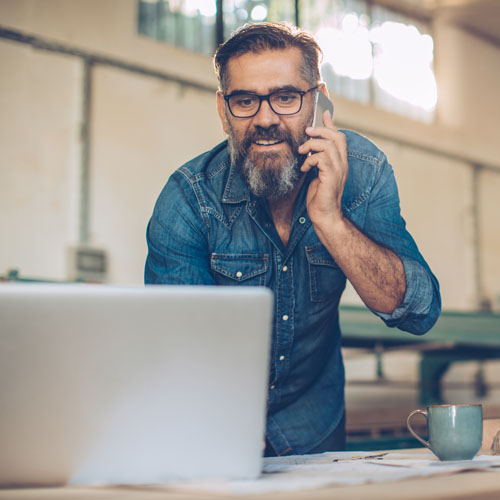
[105,450,500,494]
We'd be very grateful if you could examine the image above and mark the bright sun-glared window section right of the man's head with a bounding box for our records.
[300,0,437,122]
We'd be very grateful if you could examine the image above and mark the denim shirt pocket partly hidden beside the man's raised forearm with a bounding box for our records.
[306,243,345,302]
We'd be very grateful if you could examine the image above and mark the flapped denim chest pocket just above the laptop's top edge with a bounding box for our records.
[210,253,269,286]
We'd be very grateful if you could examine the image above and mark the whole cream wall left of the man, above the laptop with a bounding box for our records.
[0,0,224,284]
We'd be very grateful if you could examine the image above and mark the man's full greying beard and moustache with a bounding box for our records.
[228,120,308,200]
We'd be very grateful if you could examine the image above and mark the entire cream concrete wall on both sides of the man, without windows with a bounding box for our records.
[0,0,500,310]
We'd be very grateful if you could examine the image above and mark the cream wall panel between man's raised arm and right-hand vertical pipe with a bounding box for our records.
[377,135,476,310]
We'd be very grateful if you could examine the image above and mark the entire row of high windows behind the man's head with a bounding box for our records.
[138,0,437,122]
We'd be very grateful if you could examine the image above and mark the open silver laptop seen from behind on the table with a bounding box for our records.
[0,284,273,486]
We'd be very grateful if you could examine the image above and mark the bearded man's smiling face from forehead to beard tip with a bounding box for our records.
[217,48,314,199]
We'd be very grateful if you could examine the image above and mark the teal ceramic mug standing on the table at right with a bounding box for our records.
[406,404,483,460]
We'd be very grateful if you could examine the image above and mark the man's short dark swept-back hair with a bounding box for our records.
[214,22,323,92]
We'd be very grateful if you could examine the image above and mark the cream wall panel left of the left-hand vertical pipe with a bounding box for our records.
[0,41,81,279]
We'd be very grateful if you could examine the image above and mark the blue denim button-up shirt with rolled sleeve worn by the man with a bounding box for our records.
[145,131,441,455]
